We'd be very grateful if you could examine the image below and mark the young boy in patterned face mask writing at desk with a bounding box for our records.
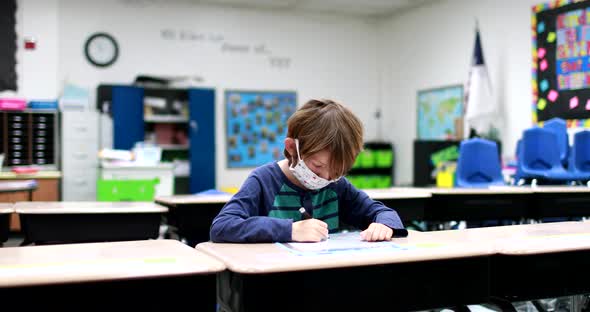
[210,100,408,243]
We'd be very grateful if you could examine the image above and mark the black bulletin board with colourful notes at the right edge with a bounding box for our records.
[532,0,590,127]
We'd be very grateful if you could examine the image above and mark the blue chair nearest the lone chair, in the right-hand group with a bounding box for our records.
[518,127,583,182]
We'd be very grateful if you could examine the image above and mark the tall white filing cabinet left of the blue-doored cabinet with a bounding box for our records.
[61,111,99,201]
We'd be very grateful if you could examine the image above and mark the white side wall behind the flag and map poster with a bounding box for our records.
[378,0,540,184]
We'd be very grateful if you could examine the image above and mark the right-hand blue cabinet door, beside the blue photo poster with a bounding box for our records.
[188,89,215,193]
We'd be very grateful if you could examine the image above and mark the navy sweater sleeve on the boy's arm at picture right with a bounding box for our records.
[340,179,408,237]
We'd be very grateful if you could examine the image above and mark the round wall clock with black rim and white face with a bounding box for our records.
[84,33,119,67]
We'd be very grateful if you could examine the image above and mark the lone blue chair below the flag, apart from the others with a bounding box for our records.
[456,138,504,187]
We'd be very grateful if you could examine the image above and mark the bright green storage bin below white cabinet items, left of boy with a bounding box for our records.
[97,179,160,201]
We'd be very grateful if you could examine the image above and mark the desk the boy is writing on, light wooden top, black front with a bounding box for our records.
[197,231,494,311]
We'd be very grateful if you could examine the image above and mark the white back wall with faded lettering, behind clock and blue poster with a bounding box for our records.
[19,0,379,187]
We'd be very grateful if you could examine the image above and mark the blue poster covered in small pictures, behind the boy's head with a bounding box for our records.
[225,90,297,168]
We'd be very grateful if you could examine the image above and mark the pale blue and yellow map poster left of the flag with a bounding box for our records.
[417,85,463,140]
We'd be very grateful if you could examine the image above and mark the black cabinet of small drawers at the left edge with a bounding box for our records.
[0,110,59,170]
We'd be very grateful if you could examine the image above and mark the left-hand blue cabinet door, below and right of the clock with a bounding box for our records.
[111,86,144,150]
